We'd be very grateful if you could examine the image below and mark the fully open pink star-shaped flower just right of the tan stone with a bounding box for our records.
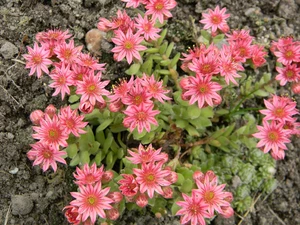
[111,29,147,64]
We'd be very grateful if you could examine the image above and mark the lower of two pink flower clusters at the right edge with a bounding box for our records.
[253,95,300,160]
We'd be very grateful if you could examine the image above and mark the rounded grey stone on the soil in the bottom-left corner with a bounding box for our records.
[11,195,33,216]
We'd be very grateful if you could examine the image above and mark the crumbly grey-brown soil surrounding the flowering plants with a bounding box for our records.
[0,0,300,225]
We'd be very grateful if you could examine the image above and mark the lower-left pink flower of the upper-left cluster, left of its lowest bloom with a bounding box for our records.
[49,64,74,99]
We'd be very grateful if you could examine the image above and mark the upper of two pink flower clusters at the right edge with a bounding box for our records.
[271,37,300,91]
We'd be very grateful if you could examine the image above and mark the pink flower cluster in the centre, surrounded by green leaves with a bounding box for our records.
[109,74,170,133]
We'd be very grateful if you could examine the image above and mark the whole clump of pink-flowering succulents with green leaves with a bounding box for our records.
[24,0,300,225]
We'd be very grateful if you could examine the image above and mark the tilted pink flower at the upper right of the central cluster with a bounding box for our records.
[141,73,171,103]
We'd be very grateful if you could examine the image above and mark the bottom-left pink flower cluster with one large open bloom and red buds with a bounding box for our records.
[64,163,123,225]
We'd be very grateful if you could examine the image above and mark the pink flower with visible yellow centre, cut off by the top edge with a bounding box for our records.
[145,0,177,24]
